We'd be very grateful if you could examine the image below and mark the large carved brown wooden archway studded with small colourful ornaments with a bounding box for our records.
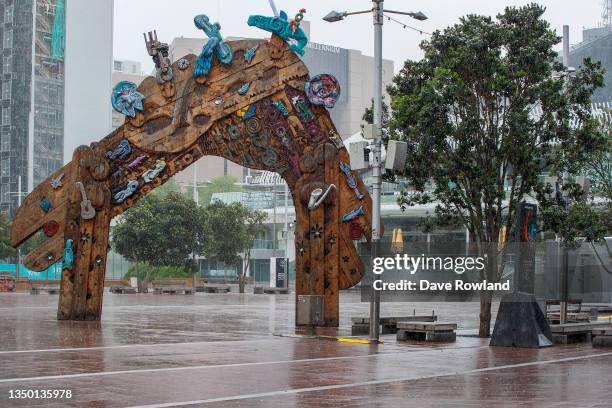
[11,20,380,326]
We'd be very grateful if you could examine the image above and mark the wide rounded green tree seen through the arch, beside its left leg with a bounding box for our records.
[111,192,208,290]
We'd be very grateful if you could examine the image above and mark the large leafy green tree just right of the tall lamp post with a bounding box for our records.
[389,4,603,337]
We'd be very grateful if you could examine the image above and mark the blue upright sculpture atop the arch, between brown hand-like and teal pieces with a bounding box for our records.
[193,14,234,78]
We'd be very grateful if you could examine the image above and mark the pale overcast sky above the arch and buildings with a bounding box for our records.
[114,0,603,72]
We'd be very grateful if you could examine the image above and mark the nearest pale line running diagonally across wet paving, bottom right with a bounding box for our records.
[129,352,612,408]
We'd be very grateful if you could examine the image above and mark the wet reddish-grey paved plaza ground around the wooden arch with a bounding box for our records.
[0,293,612,407]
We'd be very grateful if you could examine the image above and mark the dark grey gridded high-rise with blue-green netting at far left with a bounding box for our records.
[0,0,66,215]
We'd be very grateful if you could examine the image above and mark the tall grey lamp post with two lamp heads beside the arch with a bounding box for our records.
[323,0,427,342]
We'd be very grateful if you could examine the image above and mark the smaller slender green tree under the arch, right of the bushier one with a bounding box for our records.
[205,200,266,293]
